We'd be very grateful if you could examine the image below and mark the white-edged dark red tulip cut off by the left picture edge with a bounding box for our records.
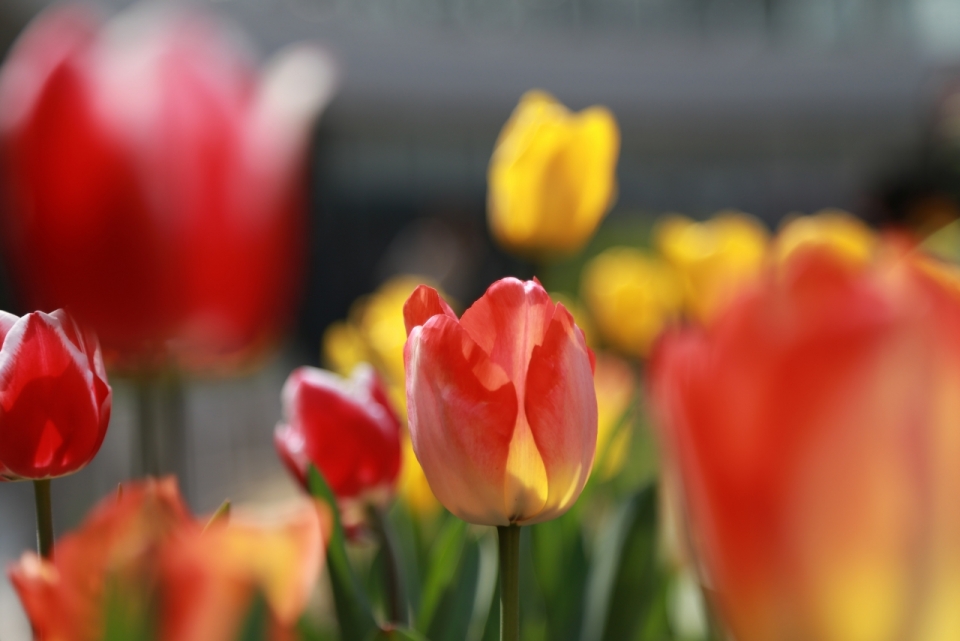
[0,310,111,480]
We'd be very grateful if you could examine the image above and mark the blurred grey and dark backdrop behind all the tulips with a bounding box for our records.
[0,0,960,641]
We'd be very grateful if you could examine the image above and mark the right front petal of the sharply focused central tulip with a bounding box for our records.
[522,305,597,524]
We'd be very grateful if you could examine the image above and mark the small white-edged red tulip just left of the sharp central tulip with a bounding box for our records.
[274,365,401,527]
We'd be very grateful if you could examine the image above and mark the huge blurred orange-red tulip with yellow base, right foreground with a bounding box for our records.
[650,242,960,641]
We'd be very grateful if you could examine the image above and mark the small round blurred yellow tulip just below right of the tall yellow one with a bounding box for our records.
[580,247,683,356]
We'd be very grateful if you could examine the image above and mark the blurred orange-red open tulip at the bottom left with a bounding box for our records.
[10,478,330,641]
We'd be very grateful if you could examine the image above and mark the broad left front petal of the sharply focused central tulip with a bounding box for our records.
[404,315,518,525]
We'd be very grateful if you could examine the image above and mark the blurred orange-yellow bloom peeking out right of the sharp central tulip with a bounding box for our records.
[593,352,637,479]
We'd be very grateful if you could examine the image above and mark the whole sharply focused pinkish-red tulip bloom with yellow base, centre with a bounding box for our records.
[404,278,597,526]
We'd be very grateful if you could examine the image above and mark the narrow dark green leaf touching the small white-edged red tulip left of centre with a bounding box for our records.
[307,465,377,641]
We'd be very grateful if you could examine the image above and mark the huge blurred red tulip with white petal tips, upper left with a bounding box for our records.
[0,6,333,365]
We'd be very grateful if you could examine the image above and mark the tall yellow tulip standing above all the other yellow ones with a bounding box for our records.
[487,91,620,257]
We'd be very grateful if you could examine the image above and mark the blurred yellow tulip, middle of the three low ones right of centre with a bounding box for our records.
[654,211,769,322]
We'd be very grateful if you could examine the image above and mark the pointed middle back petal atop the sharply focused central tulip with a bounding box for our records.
[460,278,556,390]
